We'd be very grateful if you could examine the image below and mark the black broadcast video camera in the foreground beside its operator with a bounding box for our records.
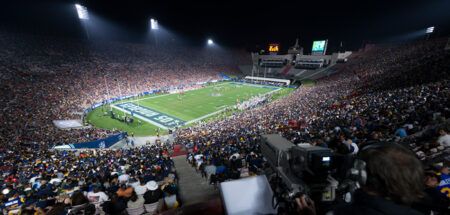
[261,134,338,209]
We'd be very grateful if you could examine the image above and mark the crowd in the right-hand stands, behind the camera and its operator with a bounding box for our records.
[175,39,450,213]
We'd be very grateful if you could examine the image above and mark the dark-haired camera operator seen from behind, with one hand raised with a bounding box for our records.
[296,144,425,215]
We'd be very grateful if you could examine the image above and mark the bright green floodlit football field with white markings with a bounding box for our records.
[87,82,292,136]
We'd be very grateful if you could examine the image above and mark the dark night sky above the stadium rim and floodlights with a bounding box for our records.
[0,0,450,50]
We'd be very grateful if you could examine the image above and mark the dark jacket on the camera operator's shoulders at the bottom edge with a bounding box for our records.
[331,190,423,215]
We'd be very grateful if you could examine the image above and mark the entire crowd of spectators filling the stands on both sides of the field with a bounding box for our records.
[0,33,450,214]
